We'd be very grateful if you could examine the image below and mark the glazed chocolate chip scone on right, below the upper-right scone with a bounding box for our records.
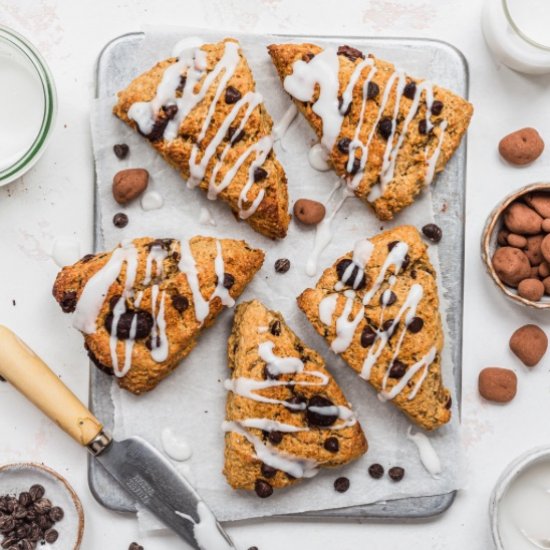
[298,226,451,430]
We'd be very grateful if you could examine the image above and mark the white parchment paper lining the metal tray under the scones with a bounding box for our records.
[92,29,461,527]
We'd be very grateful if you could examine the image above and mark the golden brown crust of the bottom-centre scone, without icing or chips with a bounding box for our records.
[224,300,367,490]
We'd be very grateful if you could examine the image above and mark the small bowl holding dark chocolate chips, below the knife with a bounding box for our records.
[0,463,84,550]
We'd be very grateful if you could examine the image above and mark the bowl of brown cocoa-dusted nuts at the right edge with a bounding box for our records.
[481,183,550,309]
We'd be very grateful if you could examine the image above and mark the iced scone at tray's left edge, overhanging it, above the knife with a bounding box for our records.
[53,237,264,394]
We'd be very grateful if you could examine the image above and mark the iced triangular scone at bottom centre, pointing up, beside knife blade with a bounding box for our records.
[224,300,367,497]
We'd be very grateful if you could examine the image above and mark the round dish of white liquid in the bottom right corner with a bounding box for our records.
[490,447,550,550]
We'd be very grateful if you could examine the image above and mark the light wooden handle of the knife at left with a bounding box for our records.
[0,325,103,446]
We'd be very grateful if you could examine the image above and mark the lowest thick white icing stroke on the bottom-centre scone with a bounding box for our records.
[222,421,319,478]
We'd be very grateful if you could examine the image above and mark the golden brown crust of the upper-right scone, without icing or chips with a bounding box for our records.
[268,44,473,220]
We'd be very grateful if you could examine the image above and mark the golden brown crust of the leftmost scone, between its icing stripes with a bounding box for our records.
[53,236,264,394]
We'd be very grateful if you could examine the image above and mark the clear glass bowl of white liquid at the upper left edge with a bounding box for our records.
[0,25,57,186]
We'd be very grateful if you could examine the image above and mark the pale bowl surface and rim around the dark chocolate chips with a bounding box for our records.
[0,462,84,550]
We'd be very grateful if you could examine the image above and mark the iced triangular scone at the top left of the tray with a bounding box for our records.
[113,39,290,238]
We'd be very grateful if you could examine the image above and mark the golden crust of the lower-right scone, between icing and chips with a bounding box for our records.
[298,226,451,430]
